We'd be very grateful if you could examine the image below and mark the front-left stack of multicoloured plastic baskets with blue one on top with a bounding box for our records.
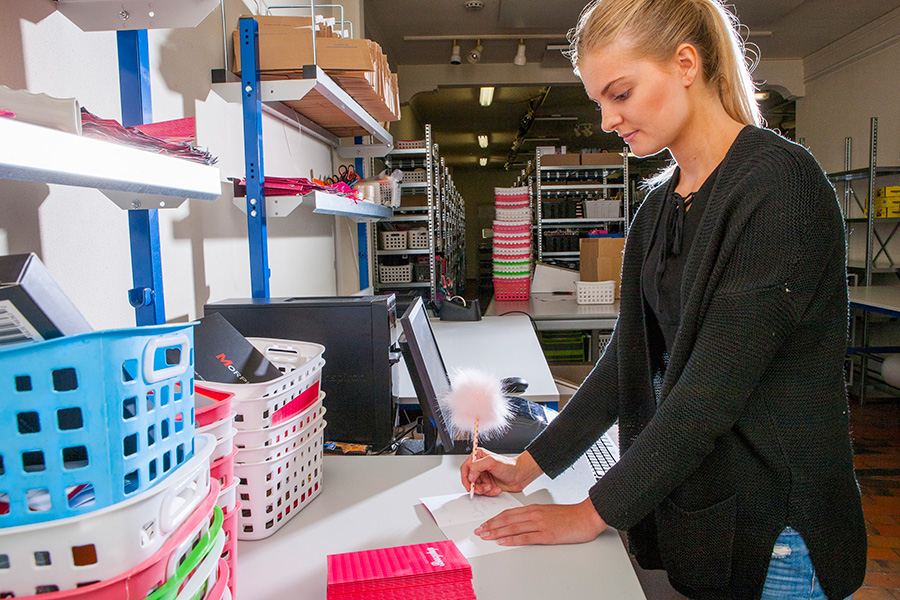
[0,325,231,600]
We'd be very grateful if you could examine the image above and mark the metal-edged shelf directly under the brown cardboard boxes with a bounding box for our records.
[212,65,394,158]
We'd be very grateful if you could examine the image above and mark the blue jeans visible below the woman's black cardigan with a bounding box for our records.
[760,527,853,600]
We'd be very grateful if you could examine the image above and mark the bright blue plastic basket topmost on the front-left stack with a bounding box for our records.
[0,325,194,527]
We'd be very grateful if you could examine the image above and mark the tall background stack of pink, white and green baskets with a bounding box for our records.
[493,187,531,300]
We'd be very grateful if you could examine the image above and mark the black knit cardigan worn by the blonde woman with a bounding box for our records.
[528,126,866,600]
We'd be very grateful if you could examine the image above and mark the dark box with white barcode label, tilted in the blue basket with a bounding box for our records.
[0,253,93,347]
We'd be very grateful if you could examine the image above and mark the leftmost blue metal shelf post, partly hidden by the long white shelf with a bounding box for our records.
[116,29,166,325]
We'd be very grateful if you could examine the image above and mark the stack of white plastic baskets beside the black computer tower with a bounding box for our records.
[198,337,326,540]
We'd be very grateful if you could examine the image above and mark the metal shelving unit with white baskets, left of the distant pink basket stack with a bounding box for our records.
[372,124,465,299]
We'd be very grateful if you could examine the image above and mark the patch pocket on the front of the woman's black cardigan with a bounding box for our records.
[656,496,737,589]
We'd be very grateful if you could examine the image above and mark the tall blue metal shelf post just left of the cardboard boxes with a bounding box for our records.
[240,18,269,298]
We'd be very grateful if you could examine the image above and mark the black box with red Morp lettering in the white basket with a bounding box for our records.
[194,313,282,383]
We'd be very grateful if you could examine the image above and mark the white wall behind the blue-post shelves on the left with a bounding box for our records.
[0,0,361,328]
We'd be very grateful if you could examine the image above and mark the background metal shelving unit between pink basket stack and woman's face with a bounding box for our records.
[532,151,631,263]
